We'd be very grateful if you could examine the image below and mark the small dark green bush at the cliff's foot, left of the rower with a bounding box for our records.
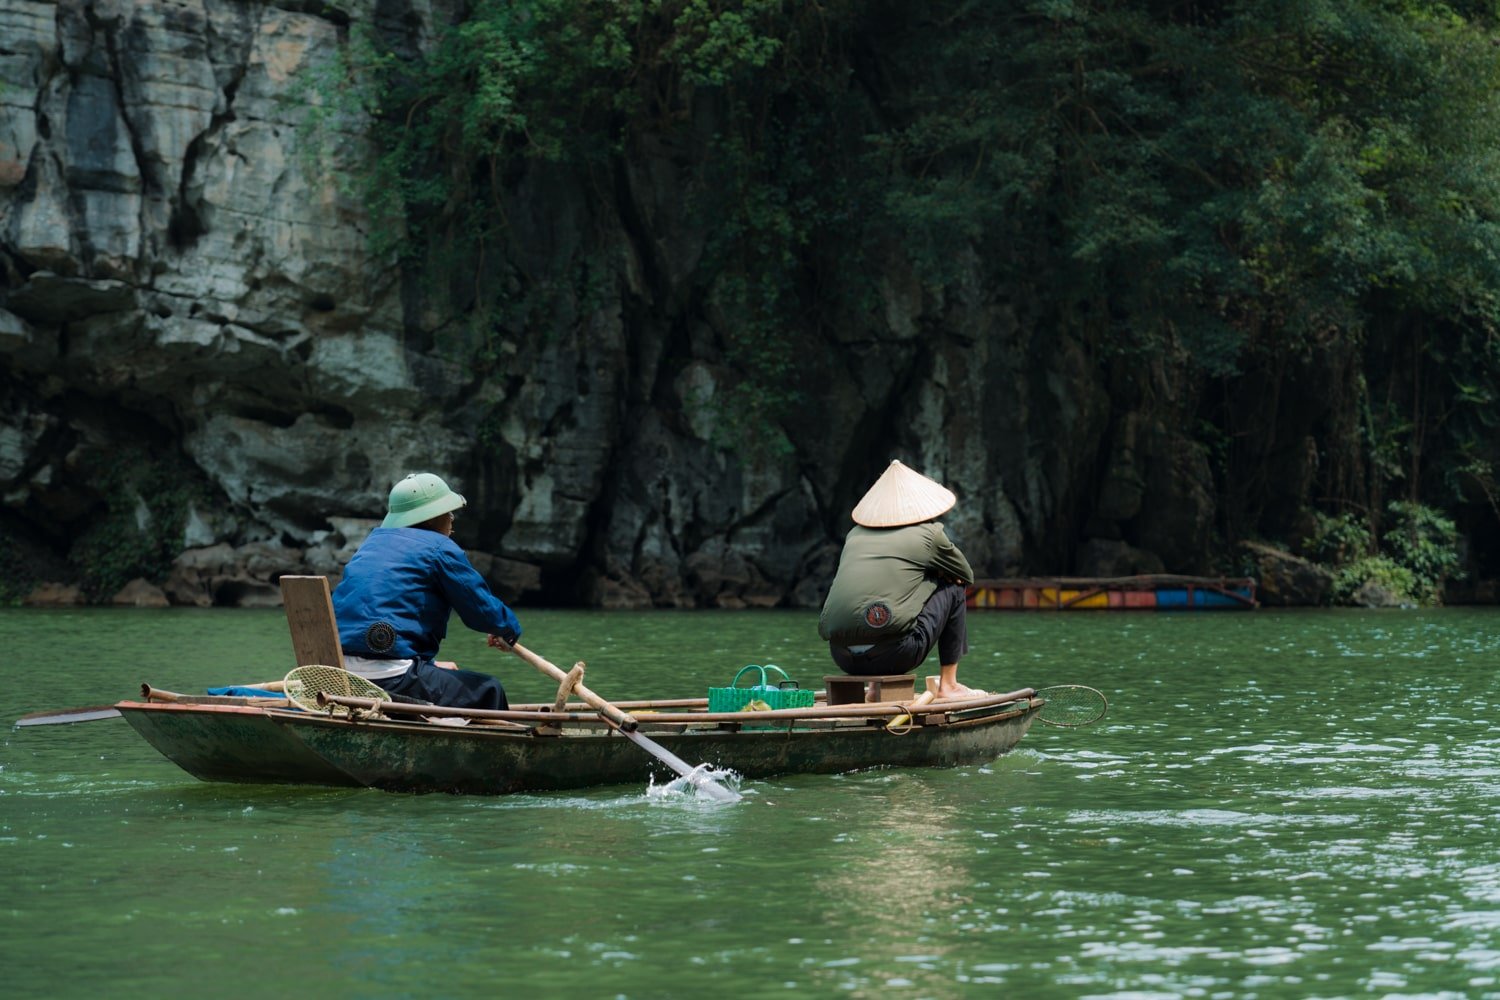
[69,448,207,601]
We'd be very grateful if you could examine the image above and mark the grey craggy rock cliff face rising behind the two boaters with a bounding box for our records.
[0,0,1214,606]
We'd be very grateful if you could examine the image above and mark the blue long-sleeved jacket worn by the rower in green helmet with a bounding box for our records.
[333,528,521,660]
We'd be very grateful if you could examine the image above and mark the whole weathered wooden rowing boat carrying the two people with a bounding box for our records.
[114,685,1044,795]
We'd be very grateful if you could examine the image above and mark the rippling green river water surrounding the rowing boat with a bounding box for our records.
[0,609,1500,999]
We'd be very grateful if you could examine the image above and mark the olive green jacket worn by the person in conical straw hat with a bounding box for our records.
[818,520,974,646]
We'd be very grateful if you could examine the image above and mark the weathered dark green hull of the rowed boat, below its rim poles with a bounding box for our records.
[119,702,1040,795]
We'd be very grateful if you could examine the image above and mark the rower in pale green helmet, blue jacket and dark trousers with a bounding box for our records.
[333,472,521,711]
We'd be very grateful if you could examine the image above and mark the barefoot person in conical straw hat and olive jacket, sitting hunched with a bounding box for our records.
[818,462,984,699]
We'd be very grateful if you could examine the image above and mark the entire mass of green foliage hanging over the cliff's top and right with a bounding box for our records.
[295,0,1500,563]
